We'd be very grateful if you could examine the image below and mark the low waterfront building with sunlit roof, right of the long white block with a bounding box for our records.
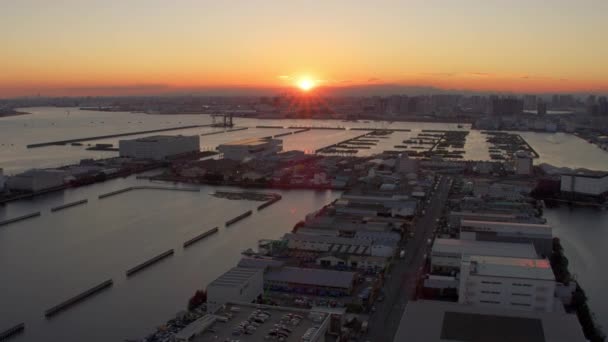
[217,138,283,160]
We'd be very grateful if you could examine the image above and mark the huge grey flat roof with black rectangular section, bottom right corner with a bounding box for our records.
[393,300,586,342]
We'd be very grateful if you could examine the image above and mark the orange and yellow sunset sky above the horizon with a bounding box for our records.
[0,0,608,97]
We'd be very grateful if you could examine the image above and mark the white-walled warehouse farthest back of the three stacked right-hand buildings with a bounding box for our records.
[460,220,553,256]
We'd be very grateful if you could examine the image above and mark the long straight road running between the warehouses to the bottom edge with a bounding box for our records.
[363,176,451,342]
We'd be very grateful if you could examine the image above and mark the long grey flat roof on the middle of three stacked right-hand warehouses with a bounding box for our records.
[433,238,538,259]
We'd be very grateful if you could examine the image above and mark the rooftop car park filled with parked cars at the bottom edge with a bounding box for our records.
[192,303,329,342]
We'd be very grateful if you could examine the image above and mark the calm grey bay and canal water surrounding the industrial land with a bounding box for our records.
[0,108,608,341]
